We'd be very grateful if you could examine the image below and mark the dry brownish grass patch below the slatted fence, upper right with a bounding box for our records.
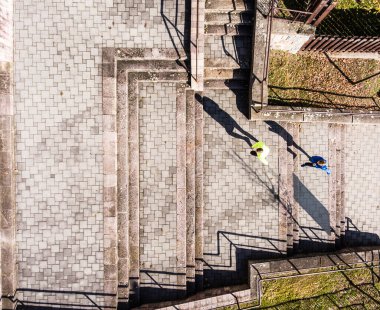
[269,51,380,110]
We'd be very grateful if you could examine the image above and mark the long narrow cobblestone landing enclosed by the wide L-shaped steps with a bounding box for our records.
[139,83,177,300]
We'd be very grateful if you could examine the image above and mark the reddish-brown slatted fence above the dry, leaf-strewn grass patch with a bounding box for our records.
[301,36,380,53]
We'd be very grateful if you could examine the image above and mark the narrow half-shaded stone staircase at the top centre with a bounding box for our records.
[204,0,253,91]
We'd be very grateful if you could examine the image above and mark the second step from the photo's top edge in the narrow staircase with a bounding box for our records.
[205,11,253,25]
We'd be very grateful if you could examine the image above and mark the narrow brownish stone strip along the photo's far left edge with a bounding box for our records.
[0,61,17,309]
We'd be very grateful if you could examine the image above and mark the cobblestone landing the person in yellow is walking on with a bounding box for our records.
[203,90,279,286]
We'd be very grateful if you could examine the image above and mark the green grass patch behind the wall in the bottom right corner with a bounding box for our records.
[262,269,380,310]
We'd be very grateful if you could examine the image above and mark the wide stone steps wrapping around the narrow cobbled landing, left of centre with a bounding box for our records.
[103,49,203,308]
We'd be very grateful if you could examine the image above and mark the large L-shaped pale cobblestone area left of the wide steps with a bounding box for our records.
[14,0,185,302]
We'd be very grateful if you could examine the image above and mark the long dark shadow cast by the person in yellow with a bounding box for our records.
[195,94,258,147]
